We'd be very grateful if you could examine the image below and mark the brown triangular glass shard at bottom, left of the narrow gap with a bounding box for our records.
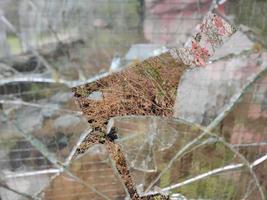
[42,145,127,200]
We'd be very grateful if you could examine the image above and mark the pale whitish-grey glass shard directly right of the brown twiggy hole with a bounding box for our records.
[174,52,267,125]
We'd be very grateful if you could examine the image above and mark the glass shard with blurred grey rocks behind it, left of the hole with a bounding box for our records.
[1,93,90,163]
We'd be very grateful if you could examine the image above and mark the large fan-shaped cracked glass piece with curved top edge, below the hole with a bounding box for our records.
[110,116,260,199]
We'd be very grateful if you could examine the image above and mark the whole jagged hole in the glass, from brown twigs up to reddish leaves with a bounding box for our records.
[73,12,235,138]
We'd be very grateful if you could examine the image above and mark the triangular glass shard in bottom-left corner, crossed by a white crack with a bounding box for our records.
[0,116,59,200]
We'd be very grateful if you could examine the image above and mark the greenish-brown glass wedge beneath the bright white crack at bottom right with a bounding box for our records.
[170,170,261,199]
